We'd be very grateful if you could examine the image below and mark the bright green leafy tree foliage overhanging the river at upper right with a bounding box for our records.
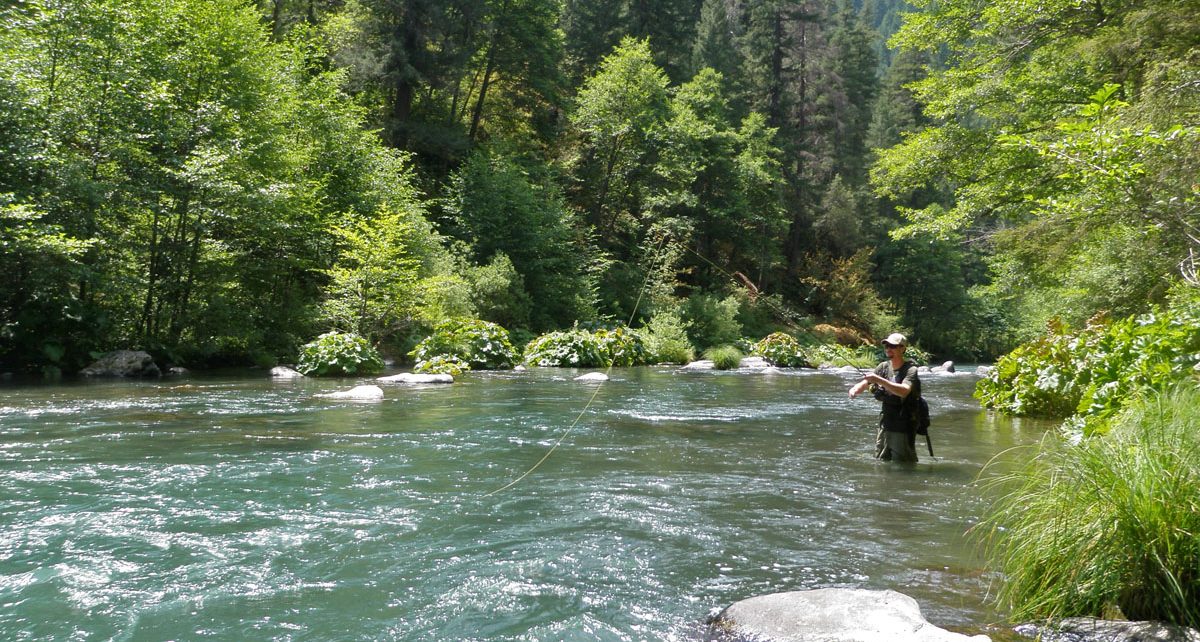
[872,0,1198,337]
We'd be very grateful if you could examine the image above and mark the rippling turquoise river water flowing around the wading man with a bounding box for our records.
[0,368,1045,641]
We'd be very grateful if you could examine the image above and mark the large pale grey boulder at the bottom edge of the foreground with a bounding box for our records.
[704,588,990,642]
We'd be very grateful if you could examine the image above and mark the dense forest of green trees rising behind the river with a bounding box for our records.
[0,0,1200,374]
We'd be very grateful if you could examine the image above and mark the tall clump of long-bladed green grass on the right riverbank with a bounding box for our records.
[978,382,1200,628]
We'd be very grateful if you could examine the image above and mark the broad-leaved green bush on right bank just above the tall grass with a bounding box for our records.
[976,301,1200,434]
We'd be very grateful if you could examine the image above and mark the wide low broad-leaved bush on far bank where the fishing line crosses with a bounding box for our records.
[526,325,646,367]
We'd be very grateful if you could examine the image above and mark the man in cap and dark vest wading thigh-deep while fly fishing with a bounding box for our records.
[850,332,920,462]
